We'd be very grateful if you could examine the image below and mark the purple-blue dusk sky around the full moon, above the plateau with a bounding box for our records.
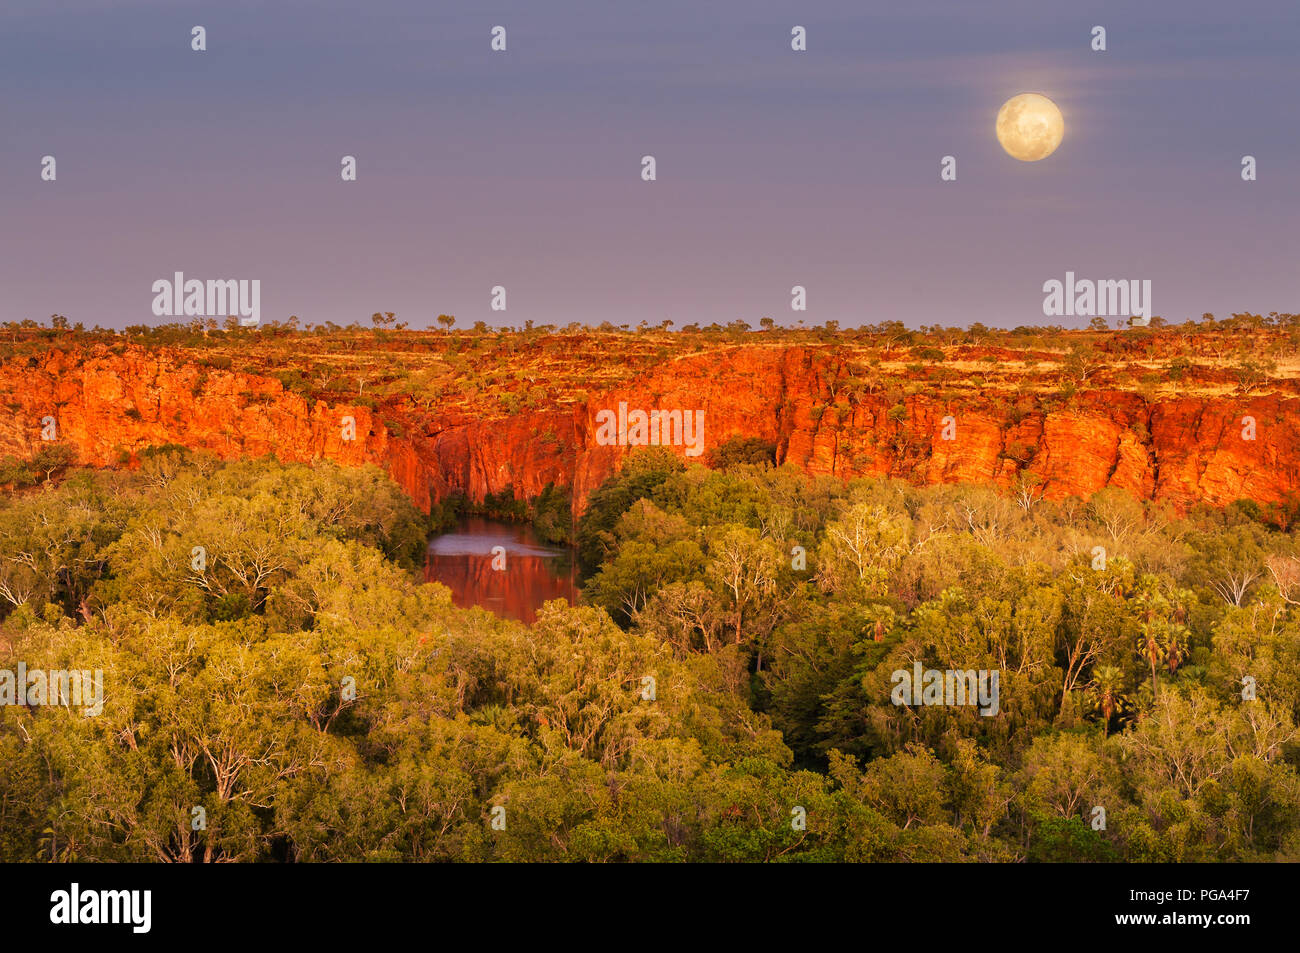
[0,0,1300,328]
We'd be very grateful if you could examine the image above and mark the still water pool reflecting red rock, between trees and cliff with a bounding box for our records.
[424,516,577,623]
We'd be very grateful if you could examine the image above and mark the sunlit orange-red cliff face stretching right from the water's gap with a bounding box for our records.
[573,348,1300,508]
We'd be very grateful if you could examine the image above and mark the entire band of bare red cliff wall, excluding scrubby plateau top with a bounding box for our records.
[0,346,1300,510]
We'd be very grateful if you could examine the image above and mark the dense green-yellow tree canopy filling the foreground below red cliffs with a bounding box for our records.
[0,447,1300,861]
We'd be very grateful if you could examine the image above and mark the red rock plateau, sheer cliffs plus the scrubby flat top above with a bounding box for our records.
[0,330,1300,514]
